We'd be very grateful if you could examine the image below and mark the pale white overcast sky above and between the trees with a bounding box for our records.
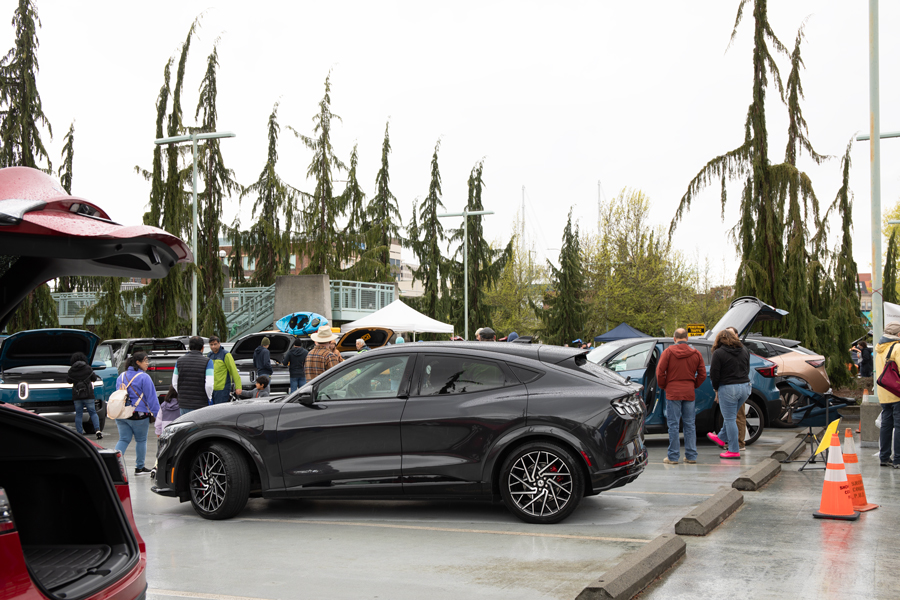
[7,0,900,283]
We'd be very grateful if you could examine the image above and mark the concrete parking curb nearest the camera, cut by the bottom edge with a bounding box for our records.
[576,534,687,600]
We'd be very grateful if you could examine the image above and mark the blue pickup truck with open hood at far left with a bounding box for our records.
[0,329,116,433]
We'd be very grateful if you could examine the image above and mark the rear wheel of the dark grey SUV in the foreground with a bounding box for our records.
[498,441,584,524]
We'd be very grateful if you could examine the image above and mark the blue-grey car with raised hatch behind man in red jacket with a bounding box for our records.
[587,297,787,444]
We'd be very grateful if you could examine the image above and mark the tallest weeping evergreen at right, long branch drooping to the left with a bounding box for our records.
[670,0,788,306]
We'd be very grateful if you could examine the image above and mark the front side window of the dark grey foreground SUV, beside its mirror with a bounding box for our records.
[316,355,409,400]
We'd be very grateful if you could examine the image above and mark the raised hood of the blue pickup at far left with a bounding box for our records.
[0,329,100,371]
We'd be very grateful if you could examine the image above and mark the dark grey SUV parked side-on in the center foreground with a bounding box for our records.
[152,342,647,523]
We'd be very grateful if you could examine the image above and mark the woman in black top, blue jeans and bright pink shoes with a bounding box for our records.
[706,329,750,460]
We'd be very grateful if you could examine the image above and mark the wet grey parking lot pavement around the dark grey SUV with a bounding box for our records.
[81,423,900,600]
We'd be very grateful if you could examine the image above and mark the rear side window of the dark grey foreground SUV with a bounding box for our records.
[419,356,507,396]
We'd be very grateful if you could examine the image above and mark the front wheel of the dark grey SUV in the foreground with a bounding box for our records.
[188,442,250,521]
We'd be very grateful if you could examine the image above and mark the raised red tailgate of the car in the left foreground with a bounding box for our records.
[0,167,193,328]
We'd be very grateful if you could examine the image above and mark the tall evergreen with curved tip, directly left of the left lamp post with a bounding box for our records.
[136,21,199,337]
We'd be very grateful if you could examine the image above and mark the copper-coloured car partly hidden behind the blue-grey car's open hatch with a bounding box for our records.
[744,336,831,427]
